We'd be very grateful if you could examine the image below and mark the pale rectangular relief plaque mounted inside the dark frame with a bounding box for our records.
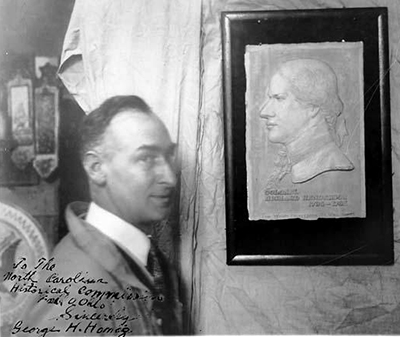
[245,42,365,220]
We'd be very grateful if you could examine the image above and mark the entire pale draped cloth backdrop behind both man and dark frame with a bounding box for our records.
[60,0,400,334]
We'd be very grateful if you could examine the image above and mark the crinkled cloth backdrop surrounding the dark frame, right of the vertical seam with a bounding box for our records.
[189,0,400,334]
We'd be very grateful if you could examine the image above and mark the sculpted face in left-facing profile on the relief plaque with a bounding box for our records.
[260,74,311,144]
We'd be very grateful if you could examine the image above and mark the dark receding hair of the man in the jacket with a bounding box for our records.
[79,95,152,159]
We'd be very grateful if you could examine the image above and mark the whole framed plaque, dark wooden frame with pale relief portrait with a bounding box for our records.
[221,8,393,265]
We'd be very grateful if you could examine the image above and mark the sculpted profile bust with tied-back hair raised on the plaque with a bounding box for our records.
[260,59,354,185]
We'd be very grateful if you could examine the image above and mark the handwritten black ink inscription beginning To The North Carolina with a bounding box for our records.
[2,257,158,337]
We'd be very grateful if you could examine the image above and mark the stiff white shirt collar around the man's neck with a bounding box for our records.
[86,202,150,266]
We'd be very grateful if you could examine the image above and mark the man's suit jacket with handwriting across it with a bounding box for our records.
[14,202,181,337]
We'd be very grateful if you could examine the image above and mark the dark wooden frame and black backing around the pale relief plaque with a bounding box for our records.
[221,7,394,265]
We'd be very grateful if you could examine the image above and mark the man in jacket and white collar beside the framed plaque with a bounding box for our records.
[12,96,181,336]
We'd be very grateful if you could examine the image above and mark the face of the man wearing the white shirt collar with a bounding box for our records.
[103,111,176,229]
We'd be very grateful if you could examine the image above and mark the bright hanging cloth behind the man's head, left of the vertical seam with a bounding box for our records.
[59,0,201,328]
